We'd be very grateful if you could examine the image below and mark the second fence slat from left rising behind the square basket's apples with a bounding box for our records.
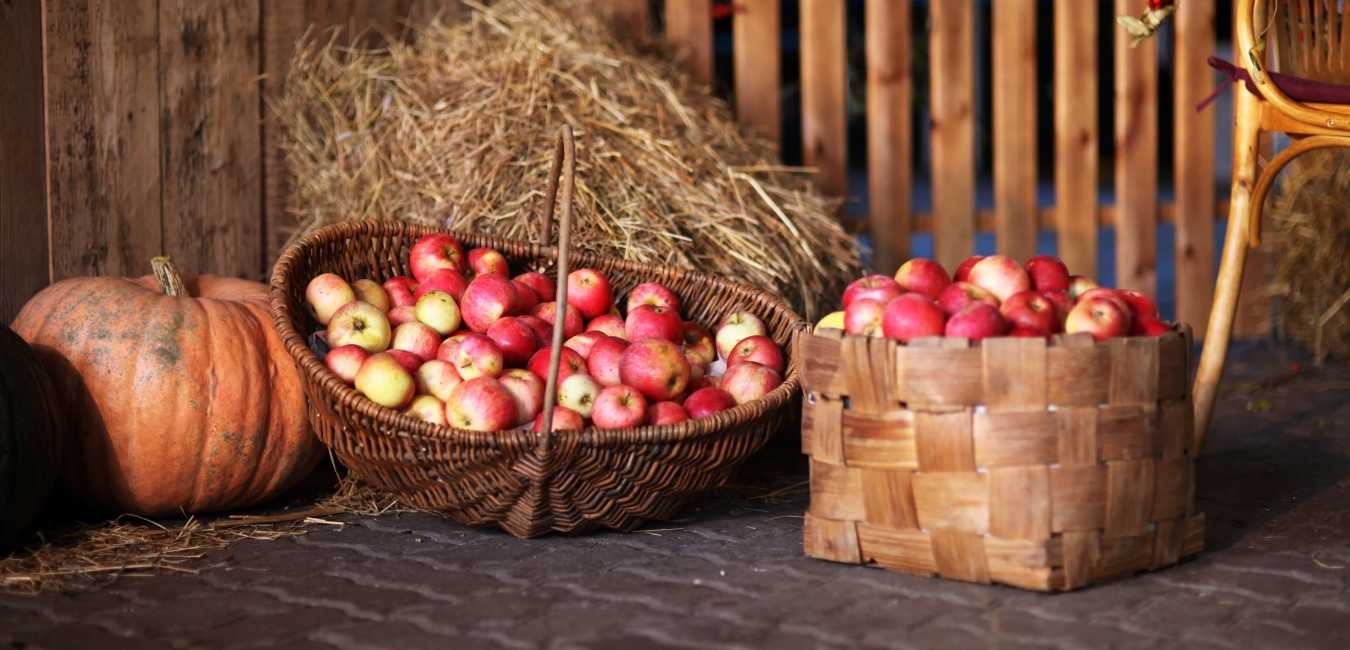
[929,0,975,269]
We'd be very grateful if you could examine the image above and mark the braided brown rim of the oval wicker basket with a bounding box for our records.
[269,220,809,450]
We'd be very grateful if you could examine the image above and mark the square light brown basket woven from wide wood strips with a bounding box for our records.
[798,330,1204,591]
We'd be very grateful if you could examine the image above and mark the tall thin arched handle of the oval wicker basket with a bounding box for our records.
[539,124,576,458]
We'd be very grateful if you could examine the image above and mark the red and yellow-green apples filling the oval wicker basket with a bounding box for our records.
[305,234,784,431]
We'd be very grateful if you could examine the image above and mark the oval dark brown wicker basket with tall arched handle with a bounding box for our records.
[271,131,803,538]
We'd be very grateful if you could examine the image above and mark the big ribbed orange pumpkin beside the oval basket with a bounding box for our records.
[14,258,321,516]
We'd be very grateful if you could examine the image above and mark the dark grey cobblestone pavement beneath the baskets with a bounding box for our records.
[0,346,1350,649]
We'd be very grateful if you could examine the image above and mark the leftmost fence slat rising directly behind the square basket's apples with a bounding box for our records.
[865,0,914,273]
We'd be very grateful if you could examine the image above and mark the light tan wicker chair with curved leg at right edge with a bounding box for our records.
[1193,0,1350,449]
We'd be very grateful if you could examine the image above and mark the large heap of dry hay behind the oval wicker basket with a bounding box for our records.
[274,0,860,318]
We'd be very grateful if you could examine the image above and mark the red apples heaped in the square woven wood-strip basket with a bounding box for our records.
[817,255,1168,343]
